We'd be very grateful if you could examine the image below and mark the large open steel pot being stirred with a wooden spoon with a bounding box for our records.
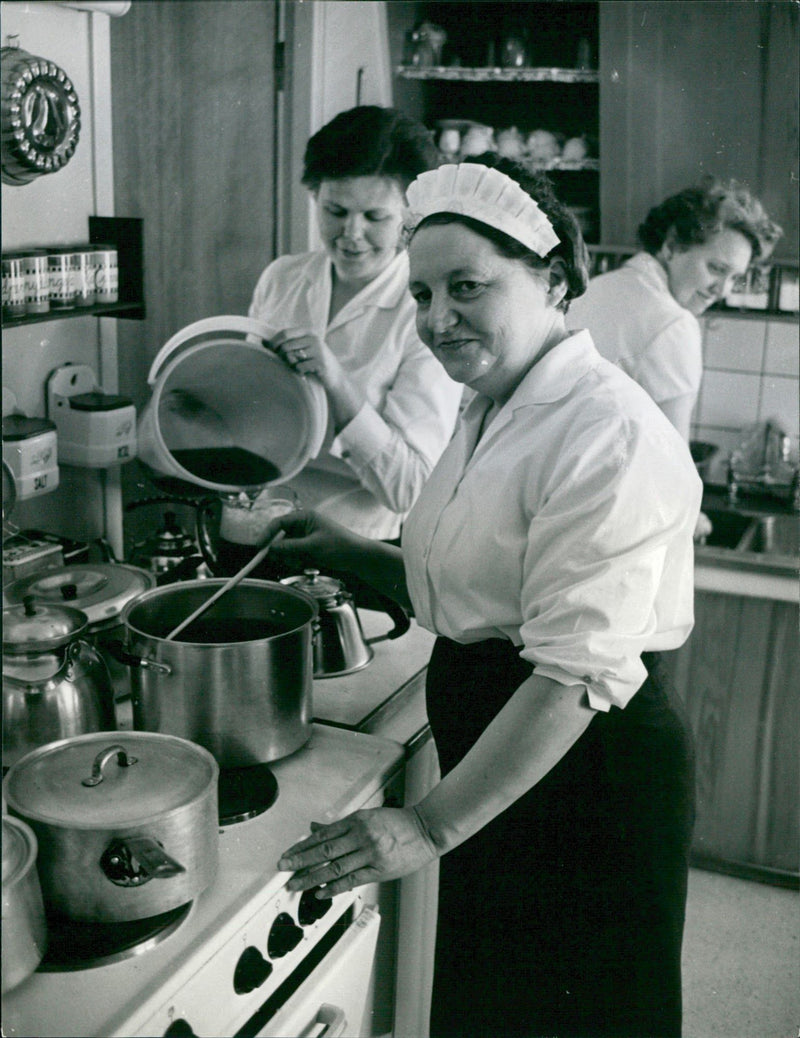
[122,579,319,767]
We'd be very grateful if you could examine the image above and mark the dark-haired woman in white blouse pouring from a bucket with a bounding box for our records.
[249,105,462,539]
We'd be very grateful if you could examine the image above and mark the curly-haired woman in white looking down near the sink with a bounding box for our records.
[568,179,781,441]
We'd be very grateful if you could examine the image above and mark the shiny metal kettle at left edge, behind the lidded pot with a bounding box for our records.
[3,595,116,769]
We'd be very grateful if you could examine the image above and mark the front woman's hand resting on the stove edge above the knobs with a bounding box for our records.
[278,808,438,898]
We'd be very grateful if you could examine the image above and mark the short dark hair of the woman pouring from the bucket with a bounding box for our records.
[302,105,441,193]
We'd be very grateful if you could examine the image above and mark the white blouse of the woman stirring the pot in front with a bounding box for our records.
[403,331,702,710]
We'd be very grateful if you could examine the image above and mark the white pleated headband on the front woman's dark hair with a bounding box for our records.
[407,162,560,260]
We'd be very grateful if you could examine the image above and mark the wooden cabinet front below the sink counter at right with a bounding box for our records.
[673,591,800,884]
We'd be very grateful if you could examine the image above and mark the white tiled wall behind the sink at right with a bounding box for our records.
[692,315,800,483]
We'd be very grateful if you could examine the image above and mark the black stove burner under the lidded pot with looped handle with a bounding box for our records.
[38,901,192,973]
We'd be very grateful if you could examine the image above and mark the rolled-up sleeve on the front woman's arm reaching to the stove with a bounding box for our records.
[520,413,701,710]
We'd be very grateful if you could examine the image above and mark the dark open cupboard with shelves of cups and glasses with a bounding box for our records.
[387,2,601,242]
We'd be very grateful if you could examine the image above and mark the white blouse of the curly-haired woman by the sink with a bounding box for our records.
[567,252,702,406]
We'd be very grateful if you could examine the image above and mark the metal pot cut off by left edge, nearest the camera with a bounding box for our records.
[2,817,47,994]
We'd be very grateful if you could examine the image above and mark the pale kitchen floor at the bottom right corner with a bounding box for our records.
[683,869,800,1038]
